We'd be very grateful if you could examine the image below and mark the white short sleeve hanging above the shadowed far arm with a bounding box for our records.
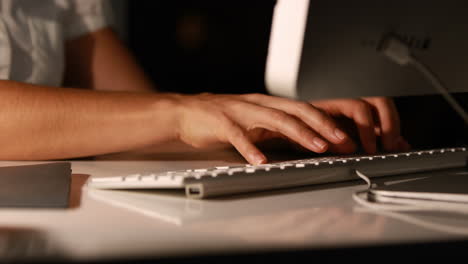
[63,0,112,39]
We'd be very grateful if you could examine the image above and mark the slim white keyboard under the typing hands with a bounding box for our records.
[88,147,468,198]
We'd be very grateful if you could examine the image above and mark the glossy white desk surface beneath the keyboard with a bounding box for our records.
[0,143,468,260]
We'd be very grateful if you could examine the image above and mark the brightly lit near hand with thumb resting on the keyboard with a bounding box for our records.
[176,94,355,164]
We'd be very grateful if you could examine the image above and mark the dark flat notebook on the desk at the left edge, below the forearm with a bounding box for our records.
[0,162,71,208]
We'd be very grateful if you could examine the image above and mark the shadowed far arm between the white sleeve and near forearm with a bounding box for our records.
[65,28,155,92]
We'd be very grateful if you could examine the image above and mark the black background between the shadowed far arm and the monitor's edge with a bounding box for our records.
[128,0,275,93]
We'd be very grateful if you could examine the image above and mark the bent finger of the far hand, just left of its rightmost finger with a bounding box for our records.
[314,99,377,153]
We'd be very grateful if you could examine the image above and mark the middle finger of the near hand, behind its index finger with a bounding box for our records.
[243,94,349,144]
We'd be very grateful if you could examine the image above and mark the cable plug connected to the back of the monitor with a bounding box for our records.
[379,35,412,65]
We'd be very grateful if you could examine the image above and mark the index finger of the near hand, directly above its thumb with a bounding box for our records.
[227,101,328,153]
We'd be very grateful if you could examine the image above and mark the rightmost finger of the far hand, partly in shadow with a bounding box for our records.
[363,98,400,151]
